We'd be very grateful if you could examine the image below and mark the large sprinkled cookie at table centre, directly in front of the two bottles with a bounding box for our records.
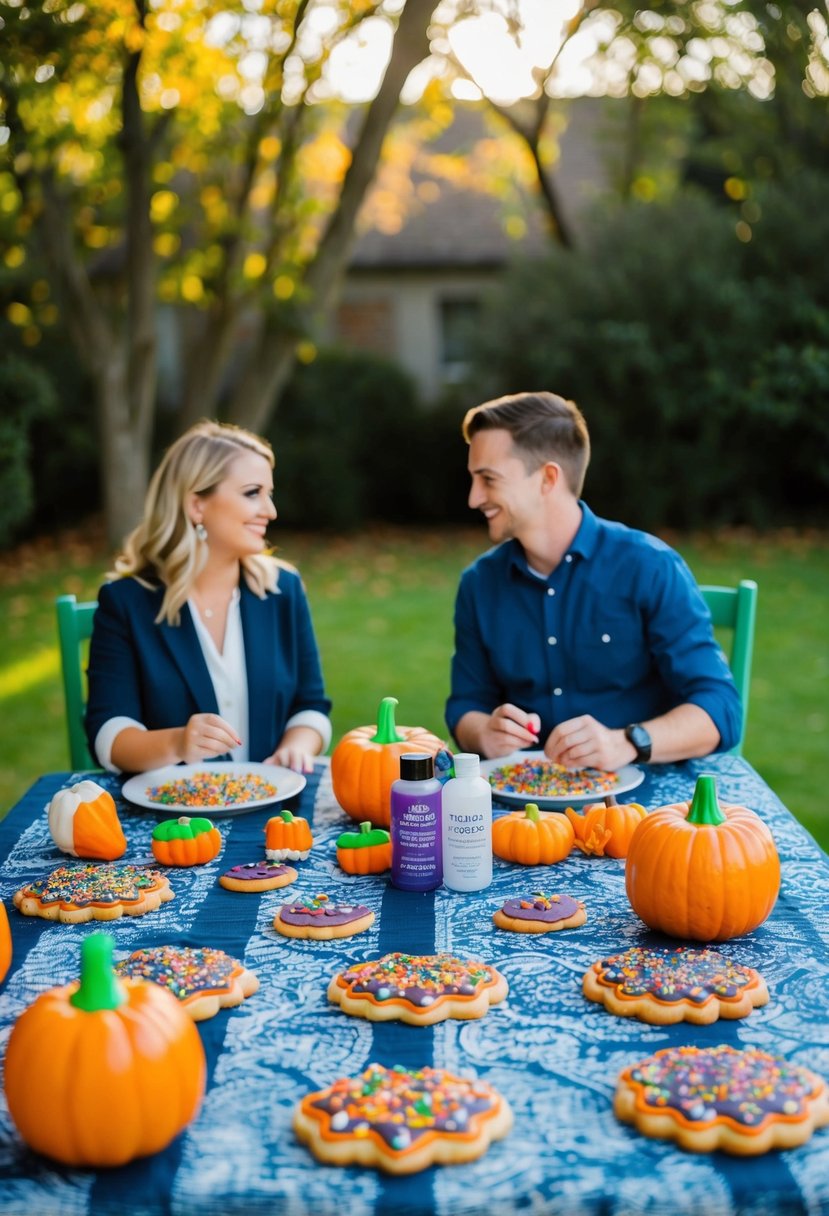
[328,952,509,1026]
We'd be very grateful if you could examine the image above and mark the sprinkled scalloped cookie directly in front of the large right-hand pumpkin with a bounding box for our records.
[582,946,768,1026]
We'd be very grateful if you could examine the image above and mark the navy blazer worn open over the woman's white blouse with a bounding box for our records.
[86,567,331,761]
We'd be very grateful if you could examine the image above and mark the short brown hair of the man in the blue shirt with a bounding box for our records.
[461,393,590,497]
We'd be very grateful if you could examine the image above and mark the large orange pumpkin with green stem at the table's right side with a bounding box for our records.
[625,773,780,941]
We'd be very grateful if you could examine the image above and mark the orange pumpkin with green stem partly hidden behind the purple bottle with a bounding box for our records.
[331,697,446,828]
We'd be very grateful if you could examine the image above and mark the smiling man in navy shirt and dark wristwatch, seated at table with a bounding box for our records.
[446,393,741,771]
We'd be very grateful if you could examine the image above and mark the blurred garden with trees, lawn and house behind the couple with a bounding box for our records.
[0,0,829,848]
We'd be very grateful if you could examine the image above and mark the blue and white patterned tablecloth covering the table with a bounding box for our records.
[0,755,829,1216]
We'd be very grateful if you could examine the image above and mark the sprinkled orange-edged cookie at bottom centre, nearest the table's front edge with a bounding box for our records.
[293,1064,513,1173]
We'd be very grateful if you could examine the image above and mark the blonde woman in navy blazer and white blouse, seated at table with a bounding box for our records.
[86,422,331,772]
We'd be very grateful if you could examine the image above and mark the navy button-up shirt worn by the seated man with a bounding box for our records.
[446,502,741,750]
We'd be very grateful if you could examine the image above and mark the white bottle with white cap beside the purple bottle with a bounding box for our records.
[441,751,492,891]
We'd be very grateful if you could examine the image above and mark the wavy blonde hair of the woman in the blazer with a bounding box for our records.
[108,422,280,625]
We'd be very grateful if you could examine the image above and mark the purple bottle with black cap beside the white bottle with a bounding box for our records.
[390,753,444,891]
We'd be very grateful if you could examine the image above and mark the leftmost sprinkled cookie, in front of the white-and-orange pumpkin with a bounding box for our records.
[13,862,174,924]
